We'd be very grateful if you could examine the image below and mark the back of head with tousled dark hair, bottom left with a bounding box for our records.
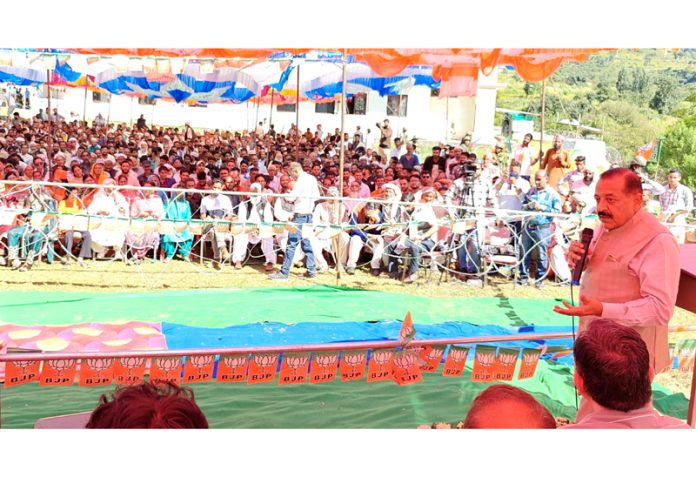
[85,382,208,429]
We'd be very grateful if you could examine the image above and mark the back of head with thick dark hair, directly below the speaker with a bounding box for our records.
[573,319,651,412]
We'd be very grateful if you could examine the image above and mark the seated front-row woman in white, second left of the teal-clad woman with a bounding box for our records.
[83,179,128,259]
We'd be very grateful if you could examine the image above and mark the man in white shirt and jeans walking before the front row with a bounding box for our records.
[269,162,320,280]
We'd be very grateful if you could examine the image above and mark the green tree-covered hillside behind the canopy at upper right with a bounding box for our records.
[497,49,696,188]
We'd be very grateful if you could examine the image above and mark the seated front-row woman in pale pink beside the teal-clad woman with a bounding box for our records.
[126,179,164,262]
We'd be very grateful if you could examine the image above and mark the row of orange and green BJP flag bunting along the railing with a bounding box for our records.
[5,312,548,387]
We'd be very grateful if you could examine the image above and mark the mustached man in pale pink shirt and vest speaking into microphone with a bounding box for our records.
[554,168,680,373]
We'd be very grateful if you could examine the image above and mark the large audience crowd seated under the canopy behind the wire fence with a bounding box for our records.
[0,117,693,282]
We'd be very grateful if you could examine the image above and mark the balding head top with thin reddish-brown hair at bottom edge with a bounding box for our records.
[463,384,556,429]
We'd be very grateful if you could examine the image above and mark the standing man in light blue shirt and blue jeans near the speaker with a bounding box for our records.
[518,171,561,288]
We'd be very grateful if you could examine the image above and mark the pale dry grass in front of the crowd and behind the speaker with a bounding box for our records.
[0,260,696,397]
